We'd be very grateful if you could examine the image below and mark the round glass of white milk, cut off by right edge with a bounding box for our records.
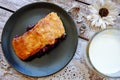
[86,28,120,77]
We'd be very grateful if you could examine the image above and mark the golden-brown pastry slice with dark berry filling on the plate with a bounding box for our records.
[12,12,65,60]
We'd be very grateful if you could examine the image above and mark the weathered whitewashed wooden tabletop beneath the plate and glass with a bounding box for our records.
[0,0,120,80]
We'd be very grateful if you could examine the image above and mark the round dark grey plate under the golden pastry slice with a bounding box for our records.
[2,2,78,77]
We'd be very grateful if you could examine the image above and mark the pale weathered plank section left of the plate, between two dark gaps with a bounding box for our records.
[0,9,12,41]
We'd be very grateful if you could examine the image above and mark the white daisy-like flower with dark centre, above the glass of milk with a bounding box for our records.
[87,0,118,29]
